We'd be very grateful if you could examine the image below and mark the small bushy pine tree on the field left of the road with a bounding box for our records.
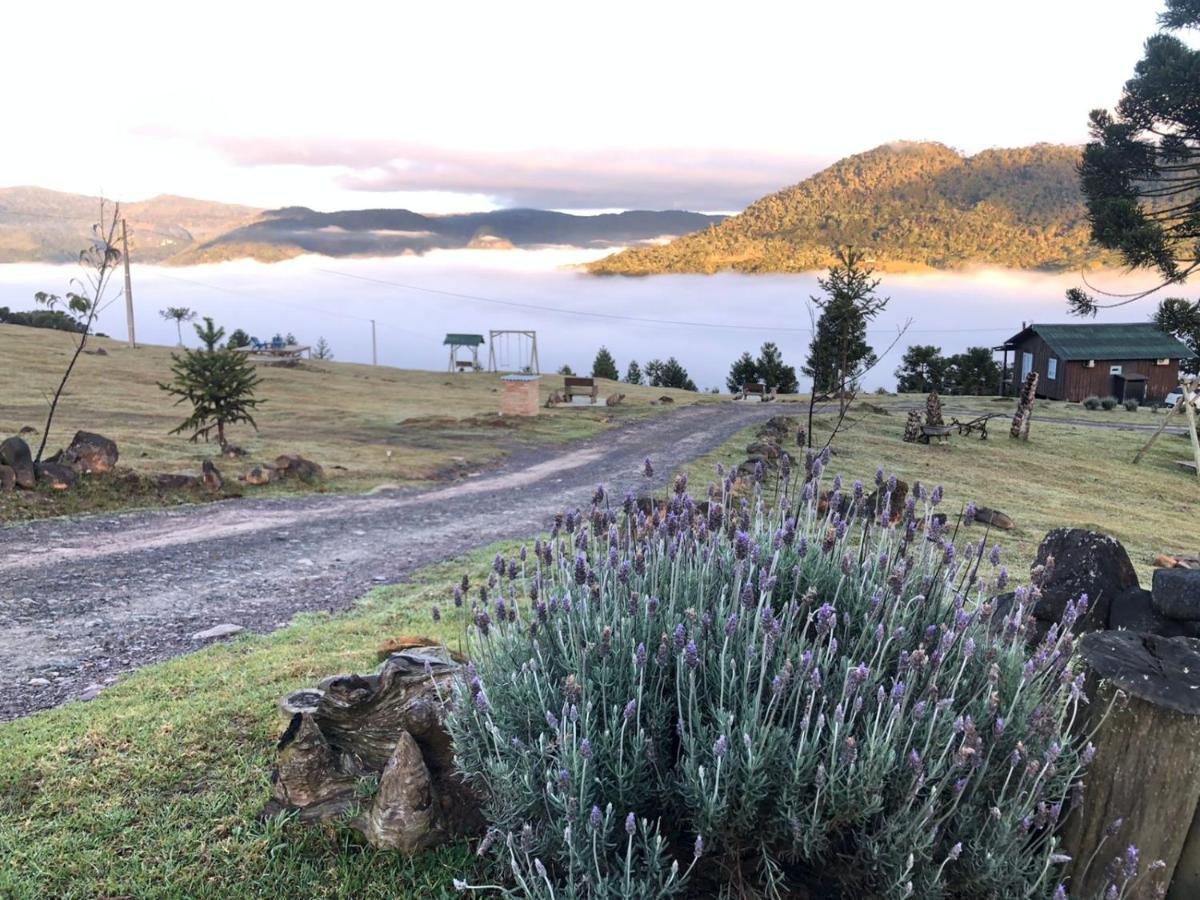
[158,317,264,448]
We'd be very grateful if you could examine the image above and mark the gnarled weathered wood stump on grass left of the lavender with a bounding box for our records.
[268,647,484,853]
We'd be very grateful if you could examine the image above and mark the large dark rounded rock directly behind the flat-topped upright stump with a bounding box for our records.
[1033,528,1139,634]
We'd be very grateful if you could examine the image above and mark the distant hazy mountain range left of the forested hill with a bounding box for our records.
[0,187,725,265]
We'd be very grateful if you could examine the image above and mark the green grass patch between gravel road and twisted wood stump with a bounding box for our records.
[0,547,525,900]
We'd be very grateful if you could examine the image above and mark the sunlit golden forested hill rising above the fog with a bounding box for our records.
[589,143,1105,275]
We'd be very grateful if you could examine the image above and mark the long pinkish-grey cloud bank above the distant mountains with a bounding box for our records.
[199,137,826,211]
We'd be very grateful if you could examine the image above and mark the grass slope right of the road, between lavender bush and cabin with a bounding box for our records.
[685,397,1200,584]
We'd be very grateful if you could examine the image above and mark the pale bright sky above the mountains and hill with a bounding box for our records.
[0,0,1176,212]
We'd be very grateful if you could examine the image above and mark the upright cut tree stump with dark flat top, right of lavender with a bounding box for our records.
[1064,631,1200,900]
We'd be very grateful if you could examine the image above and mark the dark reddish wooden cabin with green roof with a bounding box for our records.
[997,322,1193,403]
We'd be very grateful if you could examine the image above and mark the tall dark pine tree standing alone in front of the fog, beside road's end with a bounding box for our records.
[803,248,888,394]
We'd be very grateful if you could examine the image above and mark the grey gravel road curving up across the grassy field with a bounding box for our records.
[0,403,798,721]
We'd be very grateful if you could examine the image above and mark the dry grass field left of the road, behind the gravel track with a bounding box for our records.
[0,325,712,522]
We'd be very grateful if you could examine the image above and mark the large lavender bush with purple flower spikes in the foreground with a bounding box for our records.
[450,458,1091,899]
